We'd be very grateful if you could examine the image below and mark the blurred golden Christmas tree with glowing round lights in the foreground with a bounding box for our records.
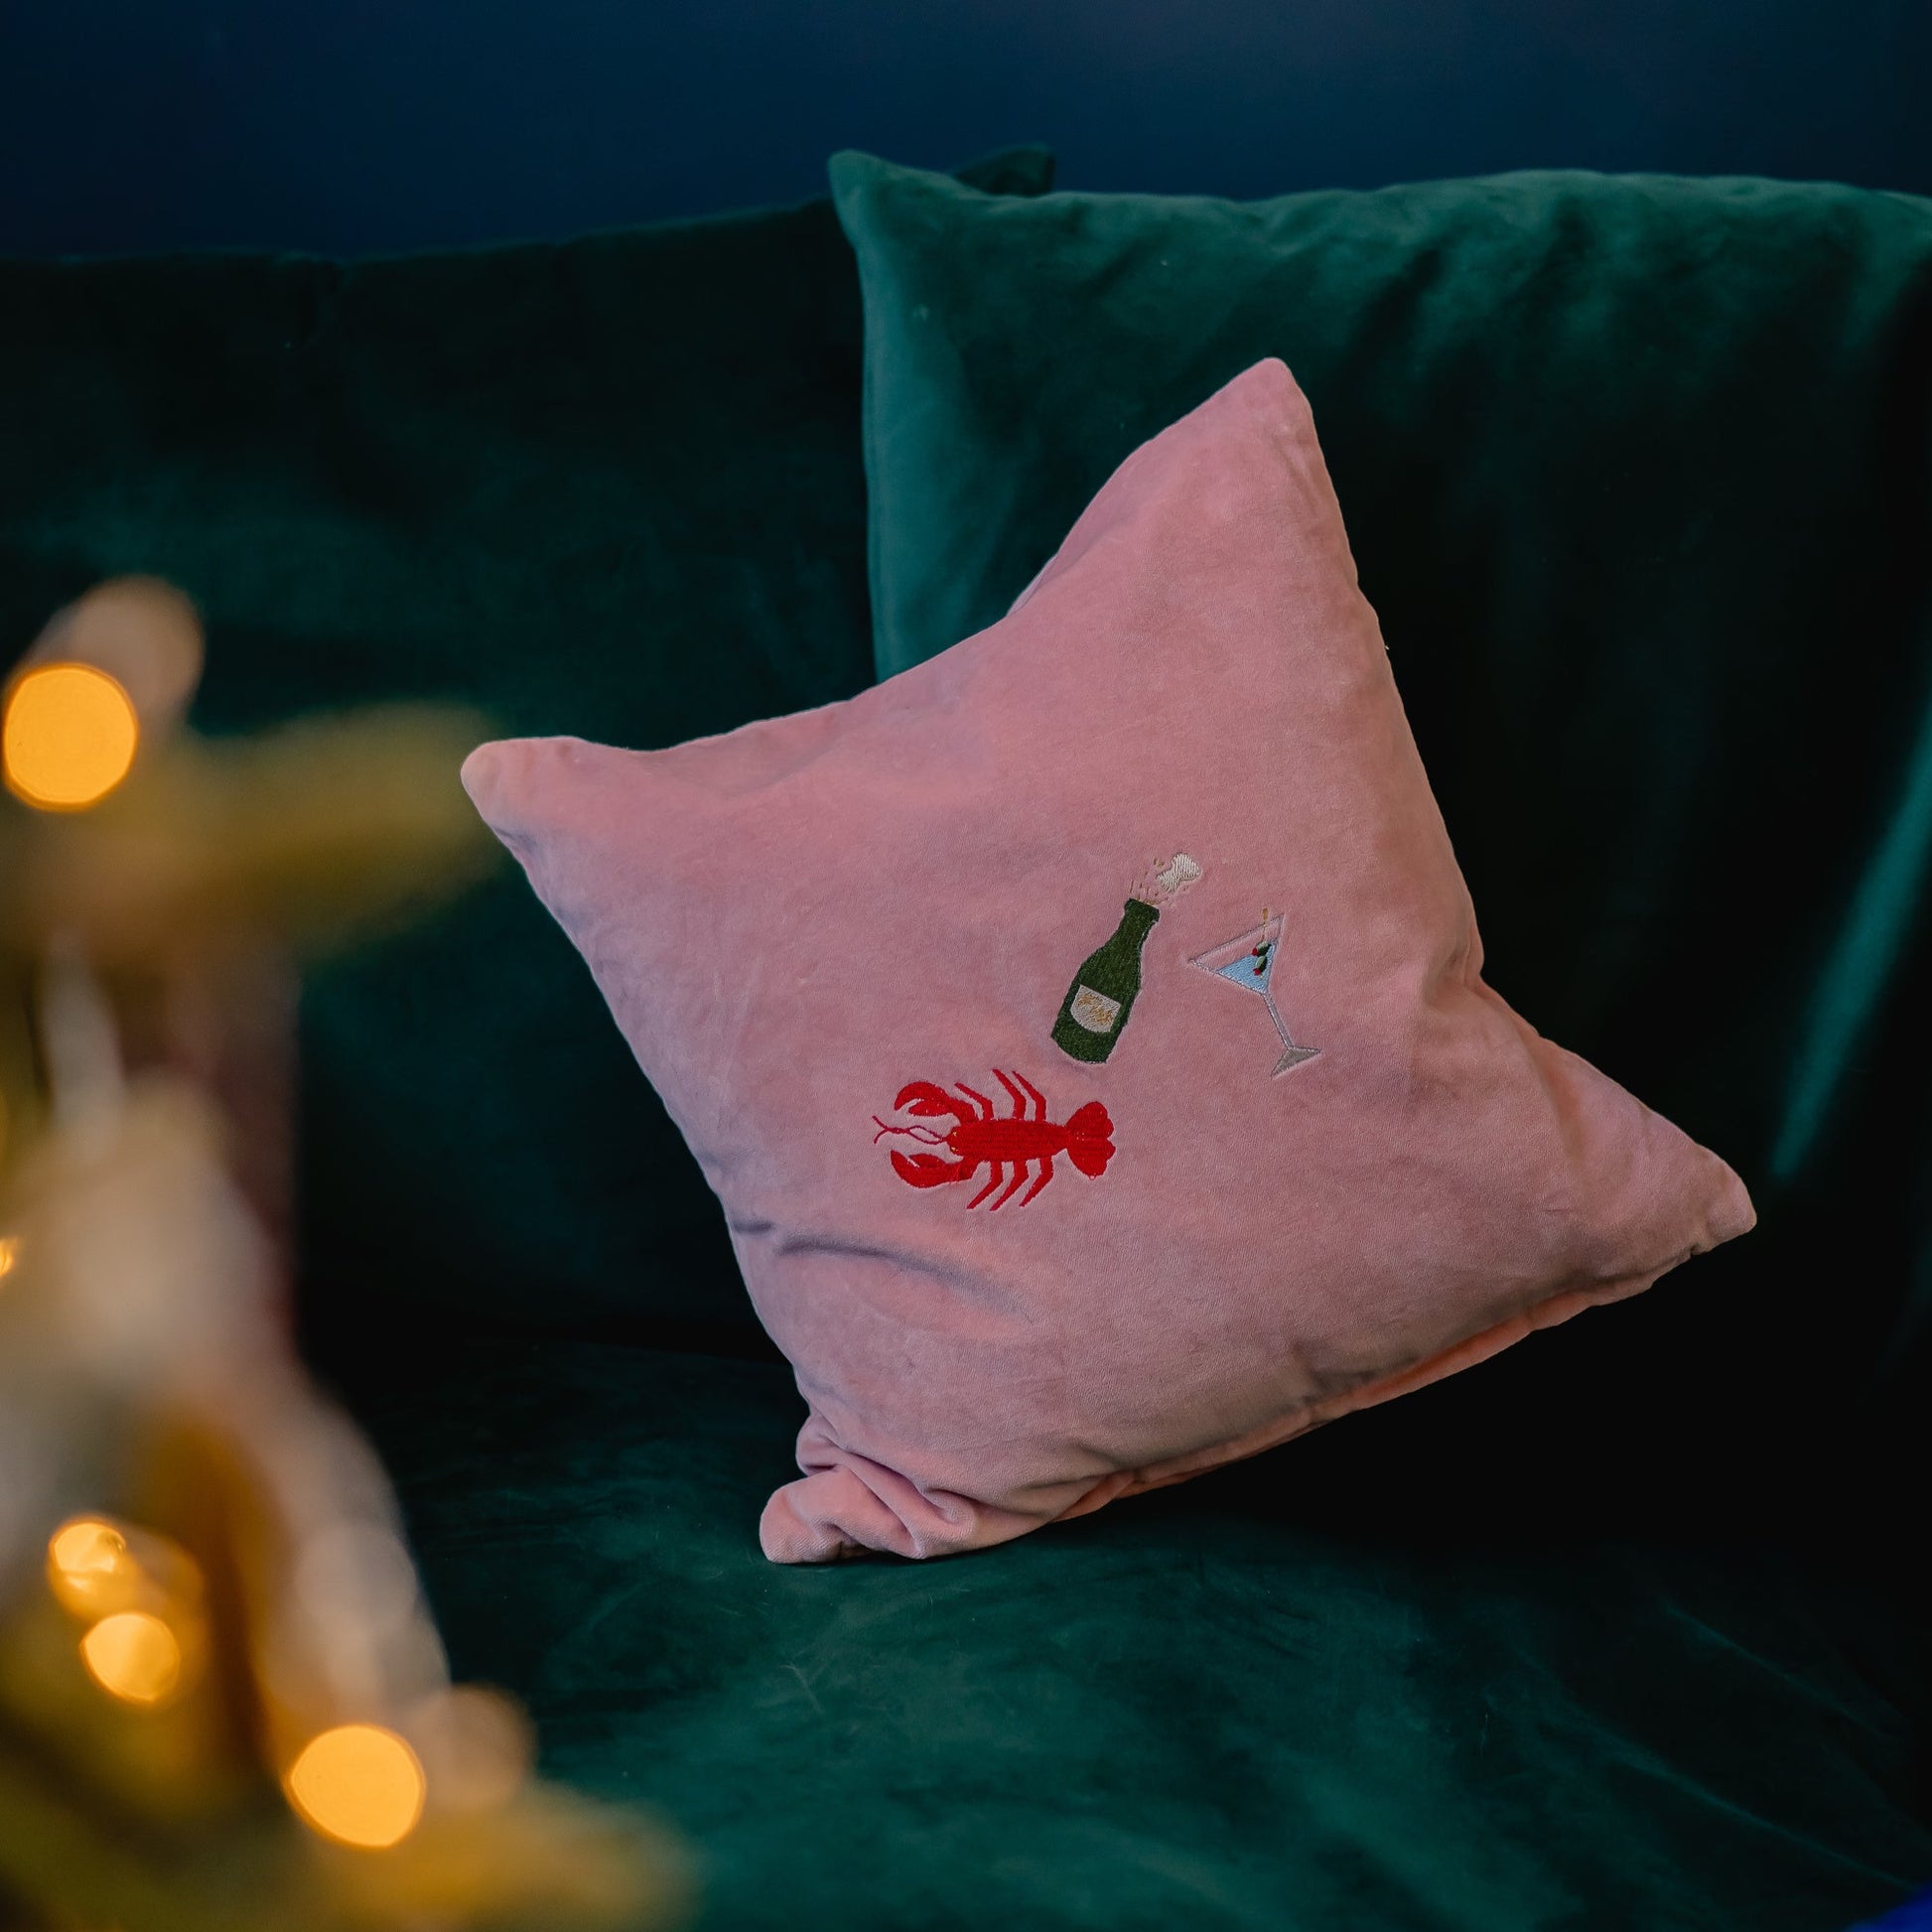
[0,578,690,1932]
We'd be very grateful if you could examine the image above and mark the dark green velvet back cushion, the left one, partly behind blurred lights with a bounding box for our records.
[0,151,1051,1331]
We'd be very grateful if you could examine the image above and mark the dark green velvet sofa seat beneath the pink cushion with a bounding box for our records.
[351,1323,1932,1932]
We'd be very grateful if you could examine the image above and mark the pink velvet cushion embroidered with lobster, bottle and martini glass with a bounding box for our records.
[464,361,1752,1563]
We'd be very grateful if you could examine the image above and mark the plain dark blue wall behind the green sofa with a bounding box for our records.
[0,0,1932,253]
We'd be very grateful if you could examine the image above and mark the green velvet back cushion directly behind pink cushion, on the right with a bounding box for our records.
[833,155,1932,1509]
